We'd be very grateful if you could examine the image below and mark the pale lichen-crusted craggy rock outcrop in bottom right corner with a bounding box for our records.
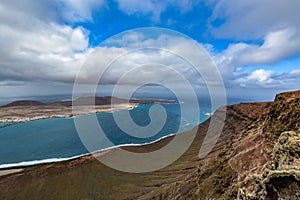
[238,131,300,200]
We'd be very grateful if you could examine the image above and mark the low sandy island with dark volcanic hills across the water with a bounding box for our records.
[0,96,176,123]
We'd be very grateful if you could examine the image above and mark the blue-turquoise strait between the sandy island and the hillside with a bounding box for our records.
[0,104,209,168]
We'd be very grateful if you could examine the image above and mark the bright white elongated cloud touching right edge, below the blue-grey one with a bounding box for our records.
[217,29,300,67]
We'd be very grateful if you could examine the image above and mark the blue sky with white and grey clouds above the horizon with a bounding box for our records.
[0,0,300,103]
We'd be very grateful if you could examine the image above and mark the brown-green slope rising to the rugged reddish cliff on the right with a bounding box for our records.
[0,91,300,200]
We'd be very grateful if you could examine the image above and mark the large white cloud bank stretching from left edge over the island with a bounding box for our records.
[0,5,217,91]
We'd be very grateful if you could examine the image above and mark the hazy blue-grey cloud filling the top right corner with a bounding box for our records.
[210,0,300,40]
